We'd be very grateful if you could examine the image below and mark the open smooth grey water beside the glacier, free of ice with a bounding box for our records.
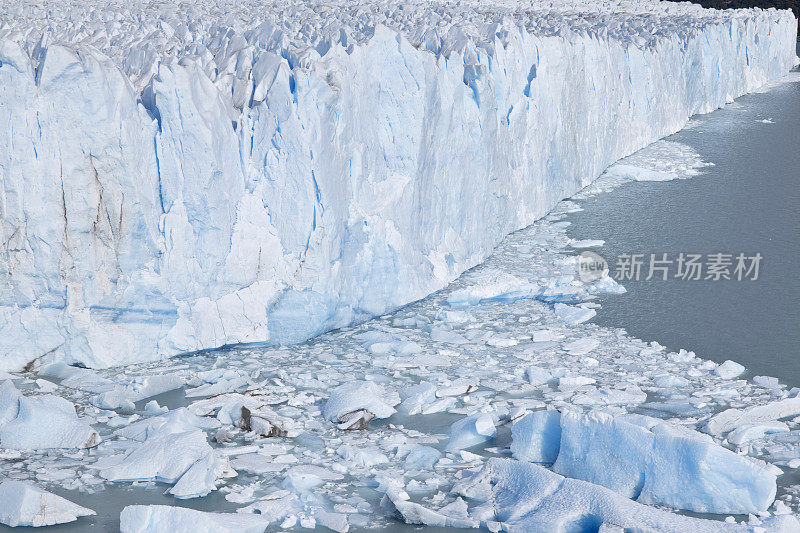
[569,61,800,386]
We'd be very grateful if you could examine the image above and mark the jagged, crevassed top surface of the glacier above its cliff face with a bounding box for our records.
[0,0,779,86]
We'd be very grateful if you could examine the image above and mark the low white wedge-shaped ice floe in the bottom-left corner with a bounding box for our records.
[0,480,96,527]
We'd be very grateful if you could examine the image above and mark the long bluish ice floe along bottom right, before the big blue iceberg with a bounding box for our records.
[453,458,800,533]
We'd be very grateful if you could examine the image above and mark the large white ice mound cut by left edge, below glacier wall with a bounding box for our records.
[0,381,101,450]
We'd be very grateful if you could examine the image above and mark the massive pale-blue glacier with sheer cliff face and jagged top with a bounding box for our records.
[0,0,797,370]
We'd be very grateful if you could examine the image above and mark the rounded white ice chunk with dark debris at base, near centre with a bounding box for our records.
[323,381,400,429]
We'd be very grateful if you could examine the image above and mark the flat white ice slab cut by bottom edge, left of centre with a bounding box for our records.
[119,505,269,533]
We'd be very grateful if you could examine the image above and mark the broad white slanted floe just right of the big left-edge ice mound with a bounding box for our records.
[100,430,213,483]
